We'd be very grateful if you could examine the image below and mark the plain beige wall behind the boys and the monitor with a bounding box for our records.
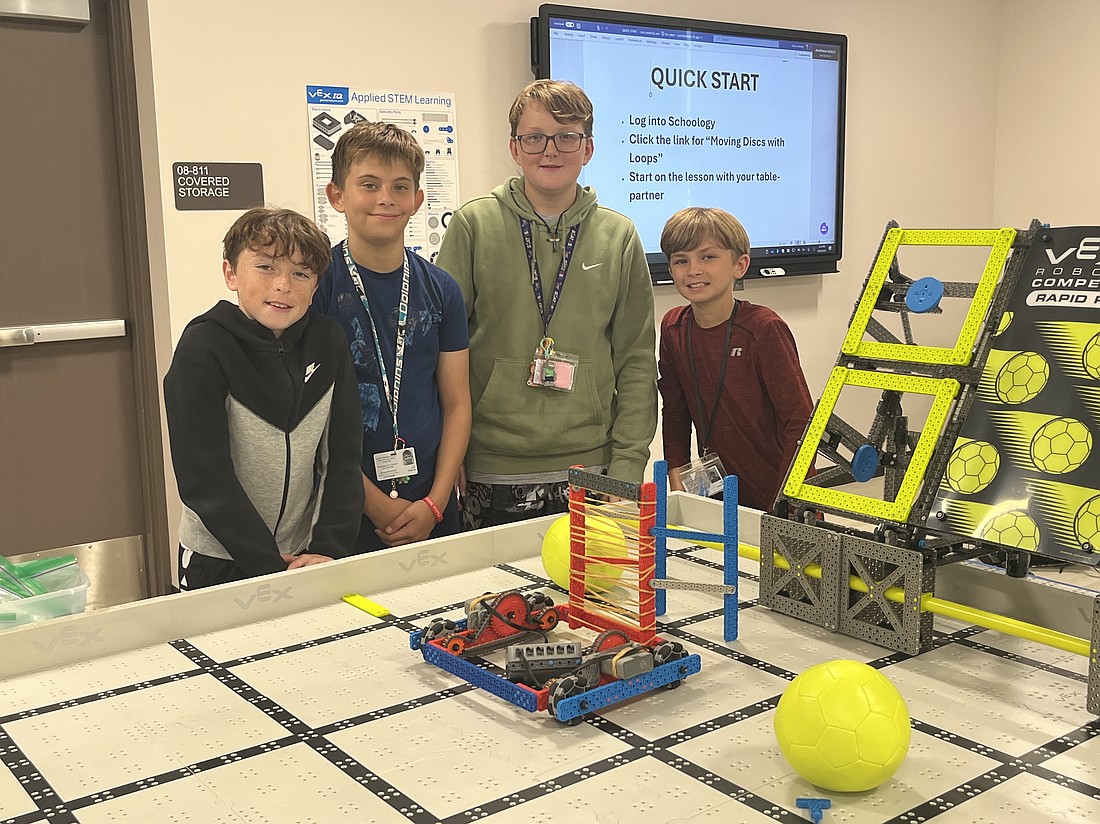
[135,0,1100,523]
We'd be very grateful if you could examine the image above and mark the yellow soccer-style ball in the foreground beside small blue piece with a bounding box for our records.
[774,660,911,792]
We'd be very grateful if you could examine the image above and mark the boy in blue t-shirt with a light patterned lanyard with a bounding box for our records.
[314,122,471,552]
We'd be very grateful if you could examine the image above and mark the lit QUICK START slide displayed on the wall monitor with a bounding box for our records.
[551,30,838,252]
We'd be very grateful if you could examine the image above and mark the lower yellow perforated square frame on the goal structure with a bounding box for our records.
[783,367,960,524]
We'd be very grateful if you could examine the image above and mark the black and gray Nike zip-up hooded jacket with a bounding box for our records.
[164,300,363,575]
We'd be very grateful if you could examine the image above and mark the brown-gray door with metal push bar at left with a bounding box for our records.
[0,0,168,605]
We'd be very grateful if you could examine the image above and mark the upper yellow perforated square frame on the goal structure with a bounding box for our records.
[840,228,1016,366]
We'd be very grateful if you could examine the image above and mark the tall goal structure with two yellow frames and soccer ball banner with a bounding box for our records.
[760,221,1100,713]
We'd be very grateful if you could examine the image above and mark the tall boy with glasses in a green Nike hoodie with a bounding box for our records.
[436,80,657,528]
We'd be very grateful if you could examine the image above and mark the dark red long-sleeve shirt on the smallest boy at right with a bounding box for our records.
[658,300,813,510]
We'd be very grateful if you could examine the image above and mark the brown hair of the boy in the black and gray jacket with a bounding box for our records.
[221,206,332,275]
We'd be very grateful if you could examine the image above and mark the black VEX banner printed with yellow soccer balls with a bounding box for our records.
[930,227,1100,554]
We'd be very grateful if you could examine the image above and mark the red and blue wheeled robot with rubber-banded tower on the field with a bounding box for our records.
[409,461,737,724]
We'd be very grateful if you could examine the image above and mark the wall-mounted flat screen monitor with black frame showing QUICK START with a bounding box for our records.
[531,6,848,283]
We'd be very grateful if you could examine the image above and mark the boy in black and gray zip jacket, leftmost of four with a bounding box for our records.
[164,208,363,590]
